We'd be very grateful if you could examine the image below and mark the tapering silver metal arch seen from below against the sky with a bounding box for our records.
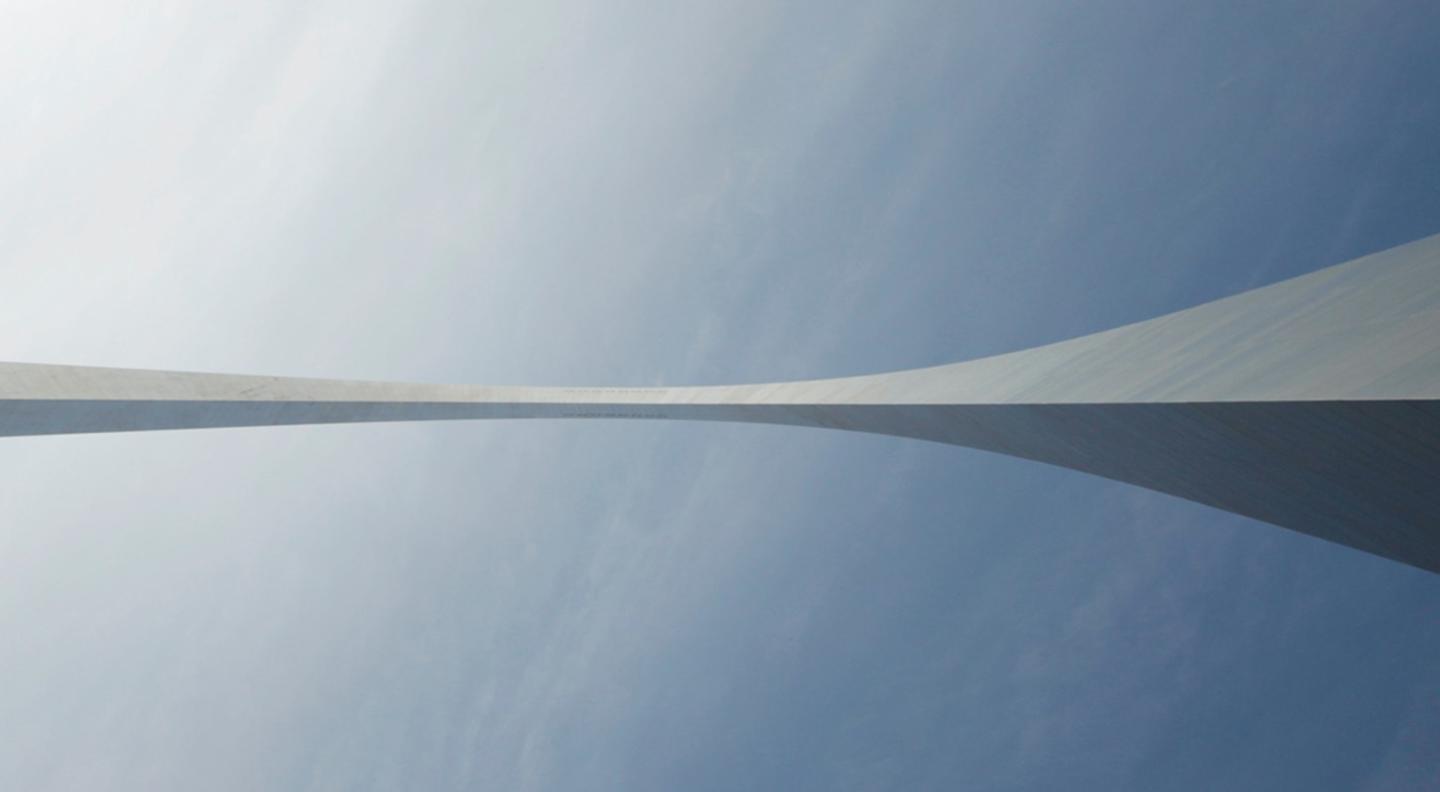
[0,235,1440,572]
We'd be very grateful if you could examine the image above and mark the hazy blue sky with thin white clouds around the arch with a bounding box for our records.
[0,0,1440,791]
